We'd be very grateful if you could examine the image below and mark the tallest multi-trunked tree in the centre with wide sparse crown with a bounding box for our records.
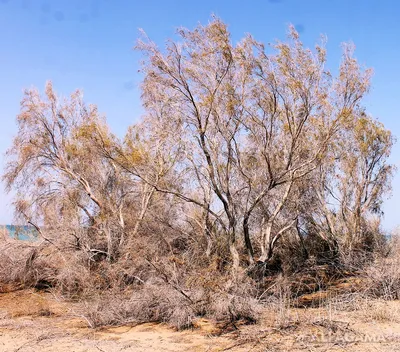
[138,19,382,270]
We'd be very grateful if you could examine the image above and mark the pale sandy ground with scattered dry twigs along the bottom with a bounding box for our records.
[0,290,400,352]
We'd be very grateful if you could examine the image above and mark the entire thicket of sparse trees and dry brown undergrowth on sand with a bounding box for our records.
[0,19,400,334]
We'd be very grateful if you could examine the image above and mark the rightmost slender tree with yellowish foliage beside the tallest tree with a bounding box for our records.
[308,45,394,251]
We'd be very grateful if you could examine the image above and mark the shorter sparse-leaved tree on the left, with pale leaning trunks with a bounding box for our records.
[3,82,130,259]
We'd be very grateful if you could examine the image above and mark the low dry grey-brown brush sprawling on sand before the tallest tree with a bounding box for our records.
[83,266,261,329]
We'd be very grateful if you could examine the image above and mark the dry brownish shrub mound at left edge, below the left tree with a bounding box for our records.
[0,238,109,298]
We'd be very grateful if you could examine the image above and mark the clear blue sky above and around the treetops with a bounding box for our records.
[0,0,400,229]
